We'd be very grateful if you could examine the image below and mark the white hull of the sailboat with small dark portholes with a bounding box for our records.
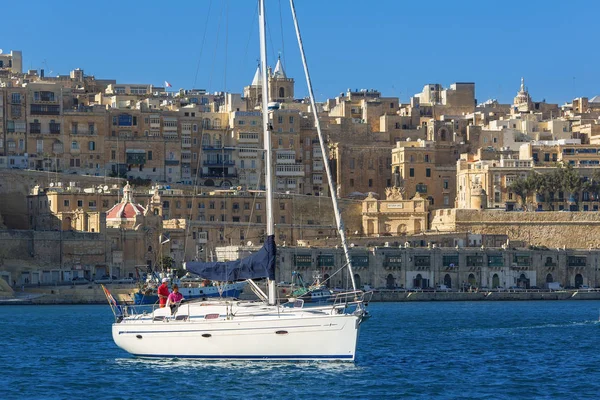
[112,302,362,361]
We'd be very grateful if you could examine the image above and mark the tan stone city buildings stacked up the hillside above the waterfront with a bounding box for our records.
[0,43,600,292]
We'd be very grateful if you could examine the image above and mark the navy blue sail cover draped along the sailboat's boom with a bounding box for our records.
[183,235,276,282]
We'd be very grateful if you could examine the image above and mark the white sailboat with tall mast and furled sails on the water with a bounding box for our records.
[109,0,368,361]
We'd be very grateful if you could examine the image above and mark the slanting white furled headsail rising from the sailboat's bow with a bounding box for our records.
[290,0,356,290]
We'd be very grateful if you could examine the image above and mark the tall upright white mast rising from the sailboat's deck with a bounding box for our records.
[258,0,276,305]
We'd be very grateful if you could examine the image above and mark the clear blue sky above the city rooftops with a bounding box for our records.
[0,0,600,104]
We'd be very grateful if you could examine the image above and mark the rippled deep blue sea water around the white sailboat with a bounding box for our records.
[0,301,600,400]
